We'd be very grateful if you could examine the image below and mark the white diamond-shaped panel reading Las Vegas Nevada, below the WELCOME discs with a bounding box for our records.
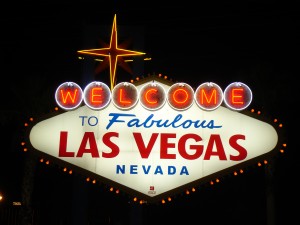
[29,79,278,201]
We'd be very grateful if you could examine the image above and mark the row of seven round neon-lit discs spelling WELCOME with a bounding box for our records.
[55,81,252,111]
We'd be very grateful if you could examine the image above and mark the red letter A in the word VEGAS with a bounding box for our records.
[204,134,226,160]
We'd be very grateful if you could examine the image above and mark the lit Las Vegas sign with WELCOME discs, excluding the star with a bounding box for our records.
[29,77,278,202]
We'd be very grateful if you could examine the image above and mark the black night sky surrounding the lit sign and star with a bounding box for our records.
[0,0,300,225]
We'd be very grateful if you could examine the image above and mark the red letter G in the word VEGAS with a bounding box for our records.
[178,134,203,160]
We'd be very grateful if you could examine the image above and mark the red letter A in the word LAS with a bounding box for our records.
[76,132,99,158]
